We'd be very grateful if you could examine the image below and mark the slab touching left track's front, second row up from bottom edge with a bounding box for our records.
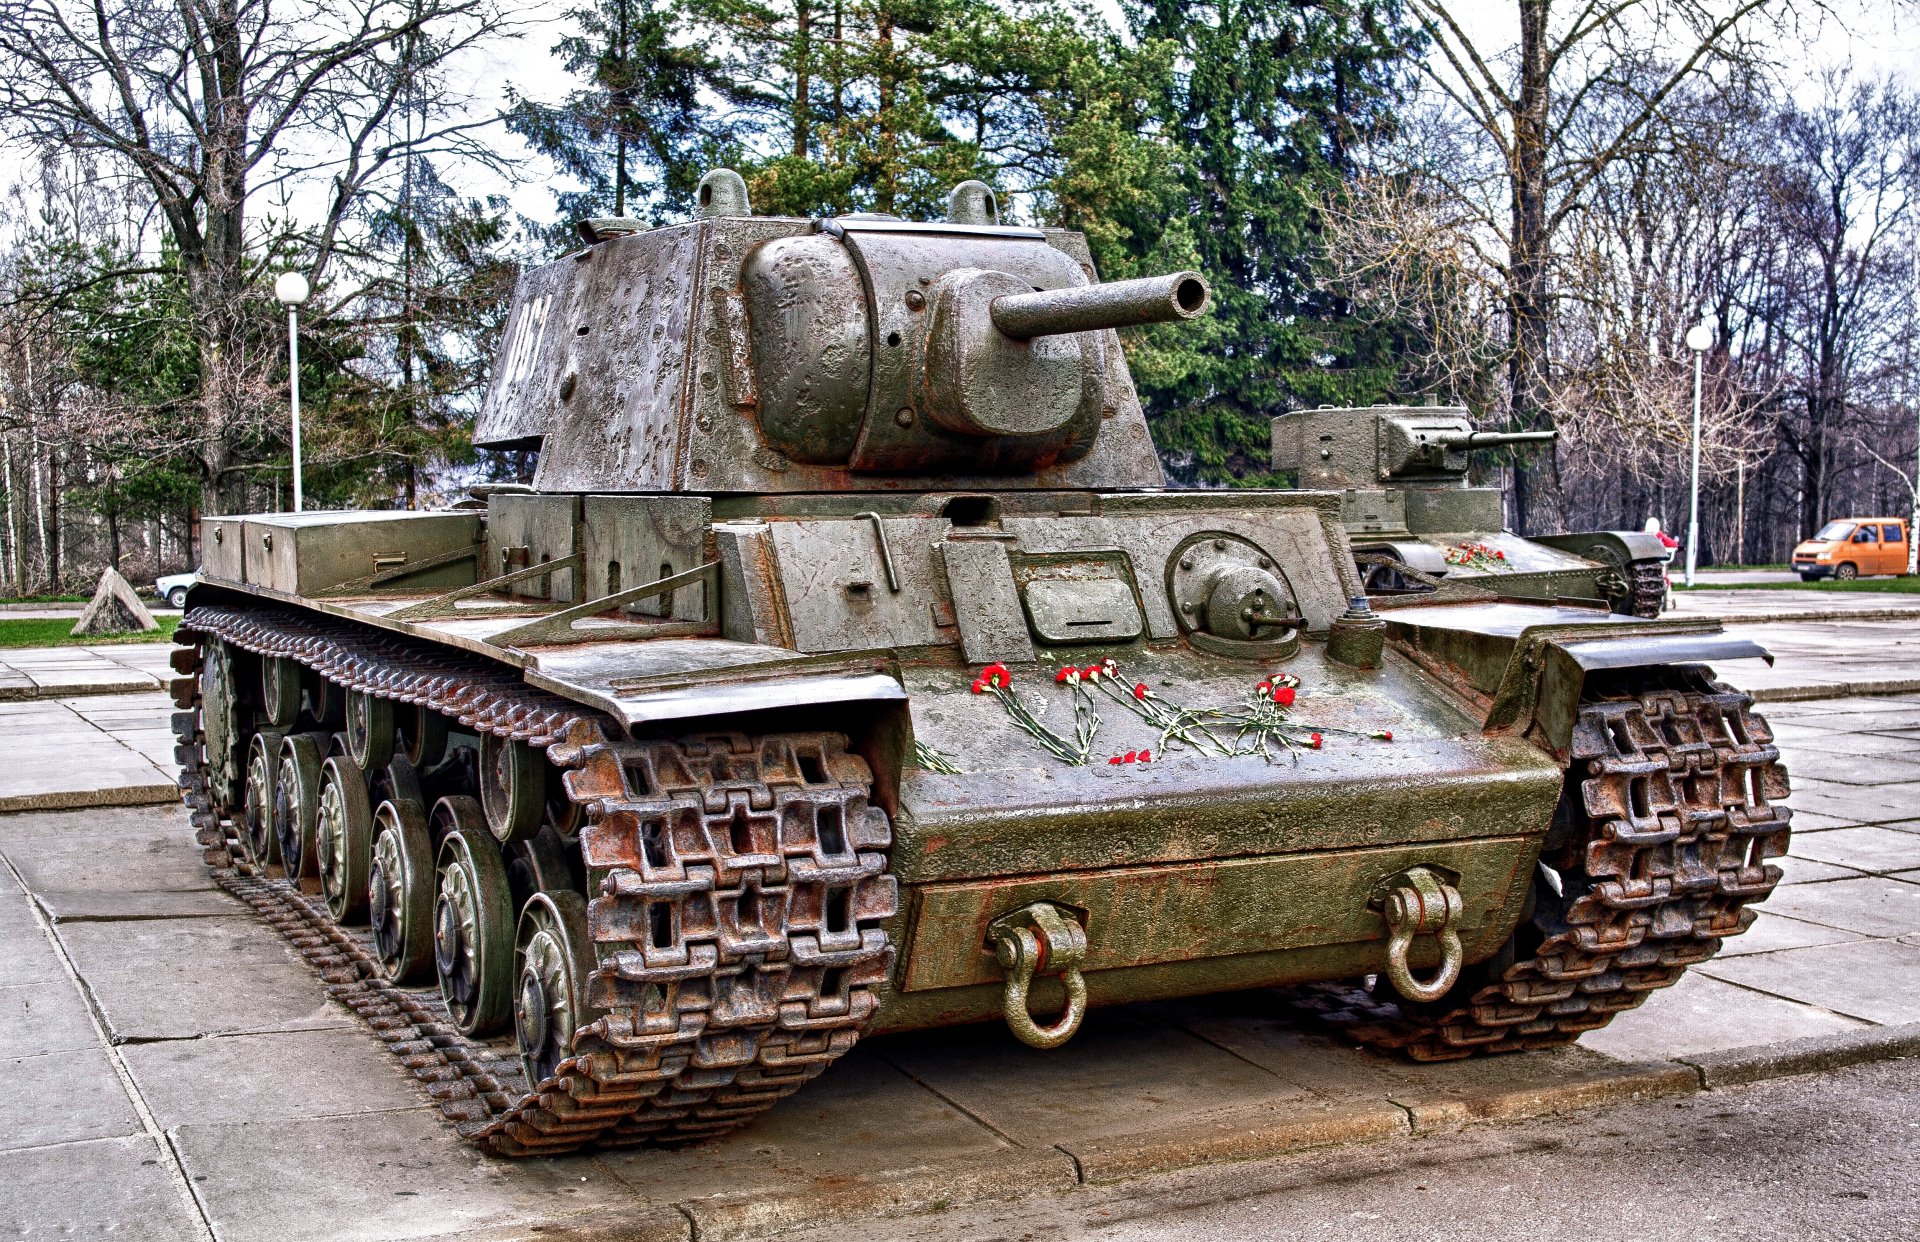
[121,1027,439,1131]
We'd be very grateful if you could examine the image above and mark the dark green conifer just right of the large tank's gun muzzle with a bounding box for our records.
[1127,0,1413,484]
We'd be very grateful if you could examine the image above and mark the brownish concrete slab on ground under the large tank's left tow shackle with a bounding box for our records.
[887,1010,1311,1144]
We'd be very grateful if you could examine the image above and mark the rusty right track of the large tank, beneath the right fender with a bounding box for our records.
[1292,670,1791,1062]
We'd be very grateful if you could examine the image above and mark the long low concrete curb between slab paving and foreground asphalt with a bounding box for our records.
[461,1023,1920,1242]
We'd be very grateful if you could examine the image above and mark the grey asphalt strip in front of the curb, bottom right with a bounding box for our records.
[833,1062,1920,1242]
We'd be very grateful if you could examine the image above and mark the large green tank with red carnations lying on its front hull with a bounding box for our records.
[173,171,1788,1156]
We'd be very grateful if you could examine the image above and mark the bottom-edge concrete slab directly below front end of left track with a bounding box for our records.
[173,1108,641,1242]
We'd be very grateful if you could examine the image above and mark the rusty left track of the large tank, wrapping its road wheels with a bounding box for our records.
[171,607,897,1156]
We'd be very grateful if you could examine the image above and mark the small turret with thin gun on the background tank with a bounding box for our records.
[1273,405,1555,490]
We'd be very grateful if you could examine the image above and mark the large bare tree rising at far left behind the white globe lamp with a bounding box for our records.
[0,0,501,518]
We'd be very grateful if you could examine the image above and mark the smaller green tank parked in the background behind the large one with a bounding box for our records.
[1273,405,1668,618]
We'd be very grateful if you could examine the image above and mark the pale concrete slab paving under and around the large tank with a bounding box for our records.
[0,671,1920,1242]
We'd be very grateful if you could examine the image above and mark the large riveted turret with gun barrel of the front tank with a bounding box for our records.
[474,171,1210,495]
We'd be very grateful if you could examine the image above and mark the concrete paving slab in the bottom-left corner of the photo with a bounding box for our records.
[0,1135,207,1242]
